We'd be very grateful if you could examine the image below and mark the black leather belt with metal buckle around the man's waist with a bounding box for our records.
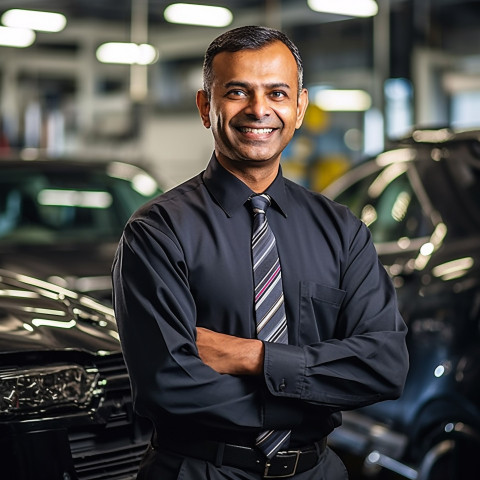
[152,437,327,478]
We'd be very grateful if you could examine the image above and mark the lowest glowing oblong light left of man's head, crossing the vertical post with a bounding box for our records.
[96,42,158,65]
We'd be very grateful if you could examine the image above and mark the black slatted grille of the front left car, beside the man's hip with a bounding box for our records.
[69,355,150,480]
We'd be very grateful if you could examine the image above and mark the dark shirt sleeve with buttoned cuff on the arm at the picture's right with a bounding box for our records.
[264,219,408,414]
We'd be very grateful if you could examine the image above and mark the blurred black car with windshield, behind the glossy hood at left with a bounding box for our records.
[0,157,161,301]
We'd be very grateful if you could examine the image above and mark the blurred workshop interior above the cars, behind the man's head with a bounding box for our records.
[0,0,480,190]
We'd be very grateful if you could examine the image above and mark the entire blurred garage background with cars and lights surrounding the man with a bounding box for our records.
[0,0,480,480]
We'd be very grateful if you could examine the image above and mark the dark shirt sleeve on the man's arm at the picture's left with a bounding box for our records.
[112,220,301,433]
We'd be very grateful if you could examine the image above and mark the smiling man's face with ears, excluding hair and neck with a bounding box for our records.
[197,42,308,168]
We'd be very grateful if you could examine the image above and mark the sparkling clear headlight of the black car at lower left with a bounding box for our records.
[0,365,99,415]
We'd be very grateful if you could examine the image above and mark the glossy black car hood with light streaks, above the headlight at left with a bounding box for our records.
[0,270,121,354]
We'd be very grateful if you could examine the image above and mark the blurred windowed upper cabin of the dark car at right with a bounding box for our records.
[333,143,480,243]
